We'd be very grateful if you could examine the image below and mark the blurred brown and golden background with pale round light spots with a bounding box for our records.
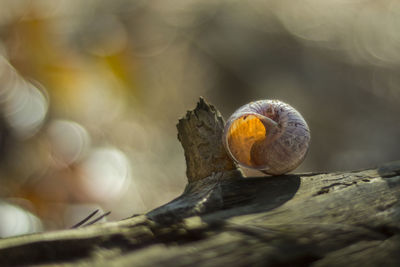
[0,0,400,237]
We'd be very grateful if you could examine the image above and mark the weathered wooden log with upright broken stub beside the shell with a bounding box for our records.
[0,99,400,266]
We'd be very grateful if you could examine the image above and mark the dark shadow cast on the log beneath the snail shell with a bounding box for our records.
[147,175,300,224]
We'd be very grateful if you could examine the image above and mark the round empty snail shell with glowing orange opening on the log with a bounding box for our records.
[223,100,311,175]
